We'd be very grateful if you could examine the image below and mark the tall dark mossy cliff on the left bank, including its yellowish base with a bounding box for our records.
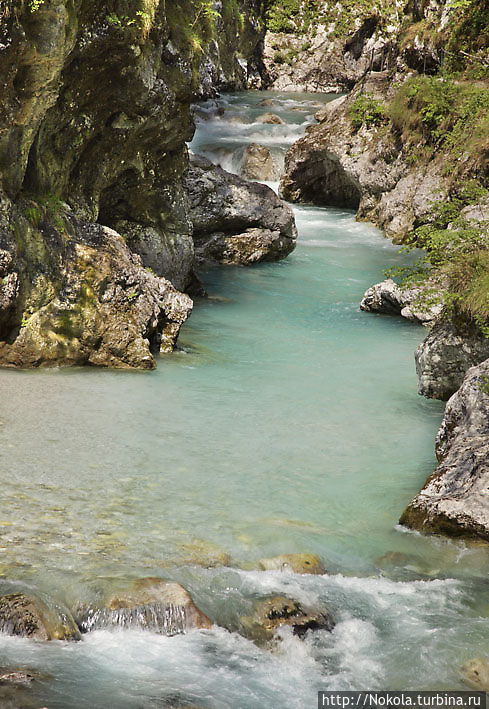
[0,0,268,367]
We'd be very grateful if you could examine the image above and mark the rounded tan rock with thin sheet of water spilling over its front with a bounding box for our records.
[77,577,212,635]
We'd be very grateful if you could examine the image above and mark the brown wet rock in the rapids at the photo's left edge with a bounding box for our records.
[0,593,80,640]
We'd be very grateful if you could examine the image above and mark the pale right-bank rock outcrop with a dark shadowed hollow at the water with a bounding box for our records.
[280,73,447,243]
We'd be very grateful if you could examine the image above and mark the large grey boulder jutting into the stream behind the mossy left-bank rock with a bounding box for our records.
[186,155,297,265]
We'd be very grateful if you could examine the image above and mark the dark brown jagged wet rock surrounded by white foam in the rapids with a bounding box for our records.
[241,596,334,644]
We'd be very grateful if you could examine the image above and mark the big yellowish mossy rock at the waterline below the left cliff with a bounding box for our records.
[0,218,192,369]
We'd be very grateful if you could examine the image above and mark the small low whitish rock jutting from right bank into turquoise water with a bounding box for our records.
[360,278,443,325]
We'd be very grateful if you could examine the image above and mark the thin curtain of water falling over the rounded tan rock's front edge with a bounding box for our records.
[78,603,189,636]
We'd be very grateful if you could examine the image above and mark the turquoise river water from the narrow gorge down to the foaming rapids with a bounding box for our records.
[0,94,489,709]
